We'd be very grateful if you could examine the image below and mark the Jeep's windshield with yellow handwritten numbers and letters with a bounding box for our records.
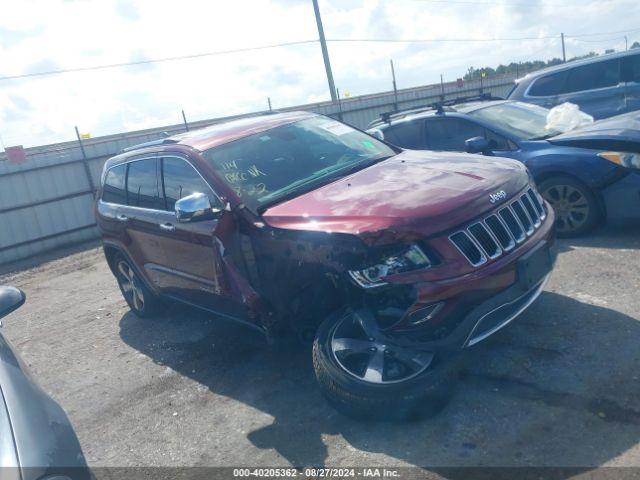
[204,117,396,211]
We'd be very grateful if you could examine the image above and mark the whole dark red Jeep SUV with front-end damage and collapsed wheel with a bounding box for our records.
[96,112,554,417]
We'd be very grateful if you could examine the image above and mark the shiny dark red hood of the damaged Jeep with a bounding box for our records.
[263,150,528,242]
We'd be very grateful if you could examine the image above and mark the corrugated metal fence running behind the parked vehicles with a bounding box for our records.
[0,76,514,264]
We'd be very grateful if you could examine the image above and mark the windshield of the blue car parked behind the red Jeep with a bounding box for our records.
[469,102,561,140]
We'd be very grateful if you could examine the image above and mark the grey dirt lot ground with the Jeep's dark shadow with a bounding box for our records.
[0,229,640,467]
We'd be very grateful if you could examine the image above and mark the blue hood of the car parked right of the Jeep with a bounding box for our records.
[549,111,640,151]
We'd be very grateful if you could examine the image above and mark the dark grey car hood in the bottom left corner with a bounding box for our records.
[0,335,87,478]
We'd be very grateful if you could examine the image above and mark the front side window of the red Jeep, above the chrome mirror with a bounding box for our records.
[162,157,217,211]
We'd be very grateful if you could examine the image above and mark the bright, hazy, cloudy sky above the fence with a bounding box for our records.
[0,0,640,147]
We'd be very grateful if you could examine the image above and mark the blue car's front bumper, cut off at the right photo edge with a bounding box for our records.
[602,172,640,225]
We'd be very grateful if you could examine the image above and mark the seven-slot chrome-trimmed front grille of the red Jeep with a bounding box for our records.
[449,188,547,267]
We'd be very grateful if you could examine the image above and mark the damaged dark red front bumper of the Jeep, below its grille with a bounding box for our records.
[380,207,556,351]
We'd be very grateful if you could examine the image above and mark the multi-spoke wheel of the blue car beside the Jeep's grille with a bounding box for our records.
[539,175,601,237]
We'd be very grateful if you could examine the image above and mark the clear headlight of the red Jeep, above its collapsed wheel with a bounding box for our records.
[349,245,433,288]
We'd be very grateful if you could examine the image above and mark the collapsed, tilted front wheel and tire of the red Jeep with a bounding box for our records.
[313,309,462,420]
